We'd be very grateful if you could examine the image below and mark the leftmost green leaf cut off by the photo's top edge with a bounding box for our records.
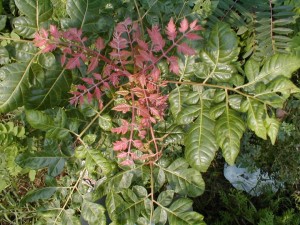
[15,0,53,24]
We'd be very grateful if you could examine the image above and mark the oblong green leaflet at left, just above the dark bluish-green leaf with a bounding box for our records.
[25,110,69,139]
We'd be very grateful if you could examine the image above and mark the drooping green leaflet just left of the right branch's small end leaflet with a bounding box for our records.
[247,99,267,140]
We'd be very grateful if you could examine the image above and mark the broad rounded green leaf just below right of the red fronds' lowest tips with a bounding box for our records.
[161,158,205,197]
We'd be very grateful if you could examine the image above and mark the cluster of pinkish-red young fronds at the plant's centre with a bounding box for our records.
[34,19,201,165]
